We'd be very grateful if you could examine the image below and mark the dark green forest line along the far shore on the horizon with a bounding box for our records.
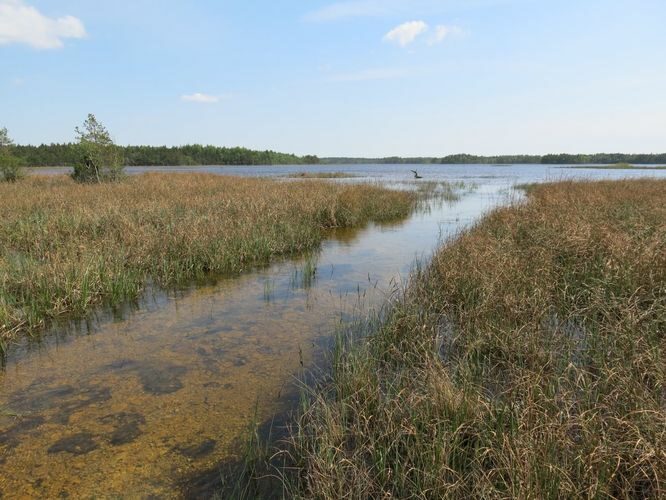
[13,143,666,167]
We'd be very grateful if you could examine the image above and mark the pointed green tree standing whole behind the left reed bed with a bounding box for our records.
[72,114,123,182]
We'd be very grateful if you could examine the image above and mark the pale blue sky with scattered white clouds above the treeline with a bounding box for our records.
[0,0,666,157]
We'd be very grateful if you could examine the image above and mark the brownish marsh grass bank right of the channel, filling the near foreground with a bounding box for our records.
[290,180,666,499]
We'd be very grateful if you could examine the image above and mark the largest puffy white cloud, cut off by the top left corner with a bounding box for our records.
[0,0,86,49]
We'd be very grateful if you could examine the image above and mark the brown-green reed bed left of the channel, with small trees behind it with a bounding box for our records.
[0,174,414,348]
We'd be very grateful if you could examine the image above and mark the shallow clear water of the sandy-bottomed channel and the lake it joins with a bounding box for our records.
[0,165,666,497]
